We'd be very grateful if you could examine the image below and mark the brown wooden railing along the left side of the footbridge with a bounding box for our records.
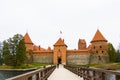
[6,66,55,80]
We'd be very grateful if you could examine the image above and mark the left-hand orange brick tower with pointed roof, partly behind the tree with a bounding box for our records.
[24,33,33,51]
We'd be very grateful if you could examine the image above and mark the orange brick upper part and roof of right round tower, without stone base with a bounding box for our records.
[91,30,108,54]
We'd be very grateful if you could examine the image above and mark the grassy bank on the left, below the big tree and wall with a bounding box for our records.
[0,63,51,69]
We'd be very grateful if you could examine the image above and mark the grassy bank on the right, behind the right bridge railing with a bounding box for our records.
[90,63,120,70]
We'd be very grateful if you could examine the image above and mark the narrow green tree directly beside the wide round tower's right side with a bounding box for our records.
[108,43,116,62]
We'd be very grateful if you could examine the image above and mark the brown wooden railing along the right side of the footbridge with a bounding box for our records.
[64,65,120,80]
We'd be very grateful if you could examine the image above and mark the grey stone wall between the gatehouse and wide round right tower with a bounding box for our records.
[67,52,89,65]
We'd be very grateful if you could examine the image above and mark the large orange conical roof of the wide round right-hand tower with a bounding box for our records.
[91,30,107,43]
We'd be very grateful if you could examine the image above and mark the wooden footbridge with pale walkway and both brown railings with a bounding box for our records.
[6,65,120,80]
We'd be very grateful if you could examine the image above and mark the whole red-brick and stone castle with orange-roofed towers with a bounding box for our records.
[24,30,109,65]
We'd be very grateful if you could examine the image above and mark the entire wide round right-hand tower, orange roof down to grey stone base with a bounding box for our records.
[90,30,108,63]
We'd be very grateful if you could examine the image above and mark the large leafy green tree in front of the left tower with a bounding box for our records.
[3,34,26,67]
